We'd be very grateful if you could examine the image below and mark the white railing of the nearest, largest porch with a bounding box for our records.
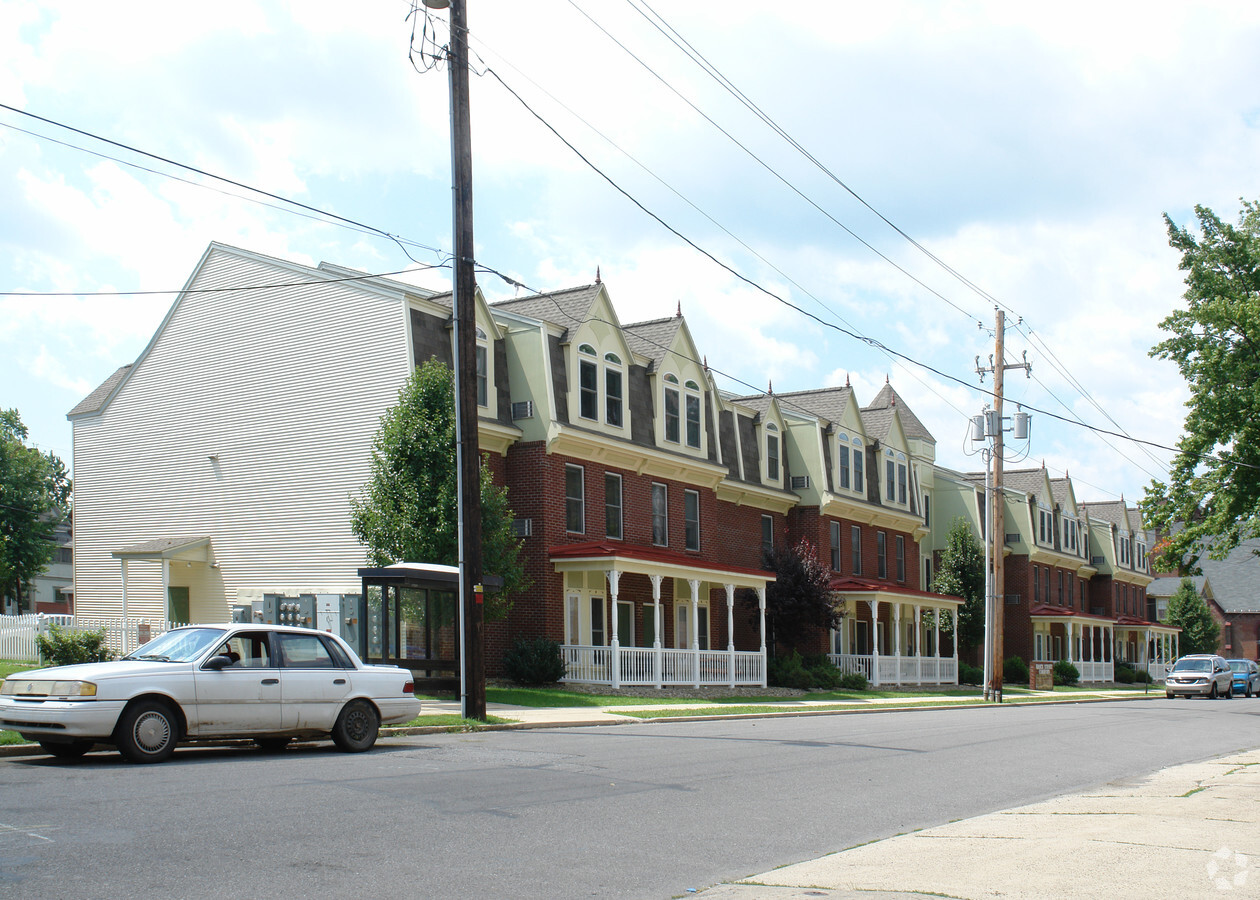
[561,644,766,687]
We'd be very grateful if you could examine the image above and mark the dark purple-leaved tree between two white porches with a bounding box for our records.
[745,538,844,653]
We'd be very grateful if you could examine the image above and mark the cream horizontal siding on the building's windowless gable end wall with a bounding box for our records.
[74,248,411,621]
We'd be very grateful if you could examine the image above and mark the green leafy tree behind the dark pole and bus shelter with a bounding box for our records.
[350,359,529,619]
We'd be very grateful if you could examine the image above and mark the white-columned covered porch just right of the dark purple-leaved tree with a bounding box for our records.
[828,577,963,686]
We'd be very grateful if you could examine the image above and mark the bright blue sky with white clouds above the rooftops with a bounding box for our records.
[0,0,1260,500]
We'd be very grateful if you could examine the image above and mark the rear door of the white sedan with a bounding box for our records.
[273,632,353,731]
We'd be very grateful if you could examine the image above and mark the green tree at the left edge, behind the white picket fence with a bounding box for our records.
[0,410,71,611]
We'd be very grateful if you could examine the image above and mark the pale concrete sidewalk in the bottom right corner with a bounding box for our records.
[702,750,1260,900]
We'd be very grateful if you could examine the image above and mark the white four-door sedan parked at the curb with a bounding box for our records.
[0,624,420,763]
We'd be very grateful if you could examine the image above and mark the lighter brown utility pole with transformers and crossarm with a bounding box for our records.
[975,309,1032,703]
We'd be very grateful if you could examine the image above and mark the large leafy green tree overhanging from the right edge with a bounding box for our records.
[1143,200,1260,572]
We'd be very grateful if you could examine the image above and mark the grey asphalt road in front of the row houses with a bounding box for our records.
[0,698,1260,899]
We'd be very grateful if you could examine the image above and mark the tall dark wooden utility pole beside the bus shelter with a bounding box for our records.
[435,0,485,721]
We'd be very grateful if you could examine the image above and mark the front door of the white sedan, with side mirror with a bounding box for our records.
[188,630,281,737]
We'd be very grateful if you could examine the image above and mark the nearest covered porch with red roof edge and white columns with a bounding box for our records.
[551,542,775,689]
